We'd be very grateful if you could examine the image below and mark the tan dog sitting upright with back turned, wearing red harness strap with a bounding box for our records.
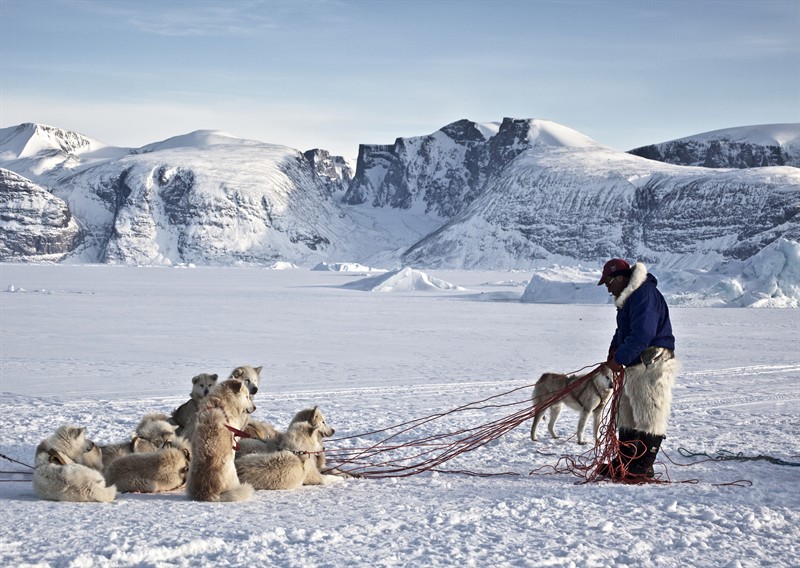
[186,379,256,501]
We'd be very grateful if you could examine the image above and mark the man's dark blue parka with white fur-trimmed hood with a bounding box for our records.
[611,274,675,367]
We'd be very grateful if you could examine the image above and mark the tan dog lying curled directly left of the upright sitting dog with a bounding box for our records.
[105,445,191,493]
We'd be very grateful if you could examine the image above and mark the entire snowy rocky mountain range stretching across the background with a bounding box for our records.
[0,118,800,306]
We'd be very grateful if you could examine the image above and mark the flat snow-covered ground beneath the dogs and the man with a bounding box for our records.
[0,264,800,567]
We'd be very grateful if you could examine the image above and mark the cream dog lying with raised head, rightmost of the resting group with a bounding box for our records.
[236,407,340,489]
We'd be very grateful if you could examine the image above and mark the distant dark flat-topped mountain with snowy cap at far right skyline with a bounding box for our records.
[630,123,800,168]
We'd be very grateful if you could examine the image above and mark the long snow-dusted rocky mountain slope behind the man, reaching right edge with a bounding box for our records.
[403,147,800,269]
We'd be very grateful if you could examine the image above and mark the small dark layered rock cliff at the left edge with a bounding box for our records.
[0,169,80,261]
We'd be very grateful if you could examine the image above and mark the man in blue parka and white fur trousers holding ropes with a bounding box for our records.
[597,258,679,481]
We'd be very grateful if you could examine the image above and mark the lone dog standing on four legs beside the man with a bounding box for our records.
[531,365,614,444]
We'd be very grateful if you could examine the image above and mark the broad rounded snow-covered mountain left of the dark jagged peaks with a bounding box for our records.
[54,145,354,264]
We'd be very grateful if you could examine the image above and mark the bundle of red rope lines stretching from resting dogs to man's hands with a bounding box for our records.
[326,364,601,478]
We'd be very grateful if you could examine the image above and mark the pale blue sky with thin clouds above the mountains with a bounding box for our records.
[0,0,800,158]
